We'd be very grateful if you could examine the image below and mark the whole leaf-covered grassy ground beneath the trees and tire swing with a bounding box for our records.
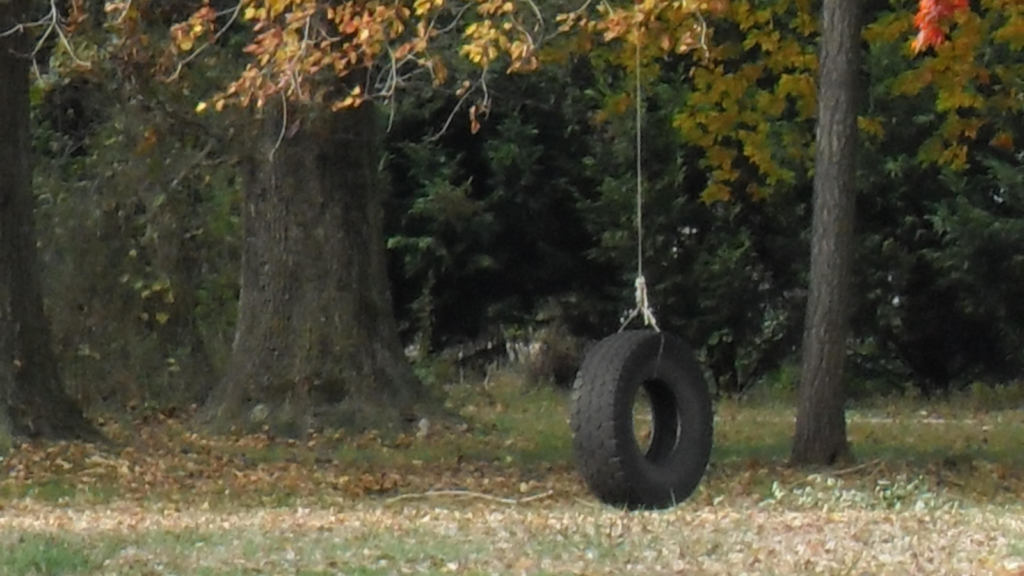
[0,380,1024,576]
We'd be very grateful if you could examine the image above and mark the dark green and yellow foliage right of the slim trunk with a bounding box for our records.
[854,19,1024,392]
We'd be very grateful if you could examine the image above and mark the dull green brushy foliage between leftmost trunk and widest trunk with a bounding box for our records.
[34,69,241,404]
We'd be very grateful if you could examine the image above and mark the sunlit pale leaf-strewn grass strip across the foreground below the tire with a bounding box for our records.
[0,501,1021,576]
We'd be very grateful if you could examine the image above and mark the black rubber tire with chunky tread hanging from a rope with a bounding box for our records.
[570,330,714,509]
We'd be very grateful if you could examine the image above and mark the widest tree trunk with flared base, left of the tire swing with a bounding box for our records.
[206,105,422,434]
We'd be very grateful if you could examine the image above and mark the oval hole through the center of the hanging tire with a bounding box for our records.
[633,380,681,463]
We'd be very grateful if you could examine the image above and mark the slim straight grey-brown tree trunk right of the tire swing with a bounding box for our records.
[792,0,860,464]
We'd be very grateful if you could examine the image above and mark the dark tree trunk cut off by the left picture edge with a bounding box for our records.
[0,0,97,439]
